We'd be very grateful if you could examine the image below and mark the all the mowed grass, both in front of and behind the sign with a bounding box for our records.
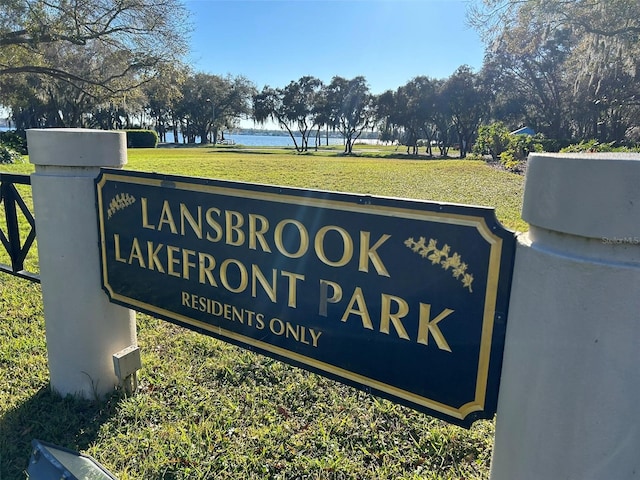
[0,147,526,480]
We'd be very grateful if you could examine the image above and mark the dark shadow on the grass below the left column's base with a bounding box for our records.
[0,387,122,480]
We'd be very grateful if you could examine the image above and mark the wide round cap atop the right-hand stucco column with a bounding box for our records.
[522,153,640,239]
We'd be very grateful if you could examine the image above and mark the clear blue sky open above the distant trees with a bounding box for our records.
[185,0,484,94]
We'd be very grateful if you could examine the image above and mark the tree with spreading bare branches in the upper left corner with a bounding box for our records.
[0,0,188,101]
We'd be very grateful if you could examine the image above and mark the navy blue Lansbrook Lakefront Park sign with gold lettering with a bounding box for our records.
[96,170,515,427]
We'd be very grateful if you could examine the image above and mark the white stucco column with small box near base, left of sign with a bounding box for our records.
[27,129,136,399]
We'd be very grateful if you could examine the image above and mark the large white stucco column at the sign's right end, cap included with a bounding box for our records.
[491,154,640,480]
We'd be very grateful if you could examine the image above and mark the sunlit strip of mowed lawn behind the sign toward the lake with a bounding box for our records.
[126,146,527,231]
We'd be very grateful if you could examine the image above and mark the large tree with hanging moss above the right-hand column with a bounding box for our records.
[469,0,640,142]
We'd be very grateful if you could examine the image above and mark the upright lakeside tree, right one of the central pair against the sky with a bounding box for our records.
[326,76,376,155]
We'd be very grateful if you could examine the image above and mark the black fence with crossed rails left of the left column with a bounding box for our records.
[0,173,40,283]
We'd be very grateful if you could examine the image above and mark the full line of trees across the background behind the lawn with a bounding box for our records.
[0,0,640,157]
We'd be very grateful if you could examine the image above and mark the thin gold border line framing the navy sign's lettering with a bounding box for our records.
[96,171,502,420]
